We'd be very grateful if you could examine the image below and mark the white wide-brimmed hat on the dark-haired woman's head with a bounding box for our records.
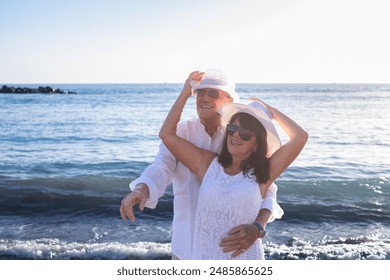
[219,101,282,157]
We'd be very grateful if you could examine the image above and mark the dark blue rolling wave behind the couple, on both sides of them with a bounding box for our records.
[0,175,390,223]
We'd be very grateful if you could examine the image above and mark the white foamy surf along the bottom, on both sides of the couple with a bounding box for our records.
[0,237,390,260]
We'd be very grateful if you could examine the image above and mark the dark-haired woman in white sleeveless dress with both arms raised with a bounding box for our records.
[160,72,308,259]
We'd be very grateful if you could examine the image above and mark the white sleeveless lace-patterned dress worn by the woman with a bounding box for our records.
[192,158,264,260]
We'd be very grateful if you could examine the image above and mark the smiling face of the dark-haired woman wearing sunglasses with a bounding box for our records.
[226,119,256,159]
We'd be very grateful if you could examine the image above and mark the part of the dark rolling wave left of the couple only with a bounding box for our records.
[0,176,173,218]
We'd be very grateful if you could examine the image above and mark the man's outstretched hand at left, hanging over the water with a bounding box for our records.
[119,183,149,222]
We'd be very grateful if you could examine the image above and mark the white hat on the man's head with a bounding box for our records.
[190,69,240,102]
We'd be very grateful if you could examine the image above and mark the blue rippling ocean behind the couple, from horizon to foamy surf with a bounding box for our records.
[0,84,390,260]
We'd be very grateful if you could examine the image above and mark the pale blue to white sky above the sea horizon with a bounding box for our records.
[0,0,390,84]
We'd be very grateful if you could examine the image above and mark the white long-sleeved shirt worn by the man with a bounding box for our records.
[130,118,284,260]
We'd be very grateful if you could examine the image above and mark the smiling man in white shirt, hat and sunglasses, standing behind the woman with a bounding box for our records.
[120,70,283,259]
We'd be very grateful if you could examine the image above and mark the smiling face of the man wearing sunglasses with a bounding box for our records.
[195,88,233,120]
